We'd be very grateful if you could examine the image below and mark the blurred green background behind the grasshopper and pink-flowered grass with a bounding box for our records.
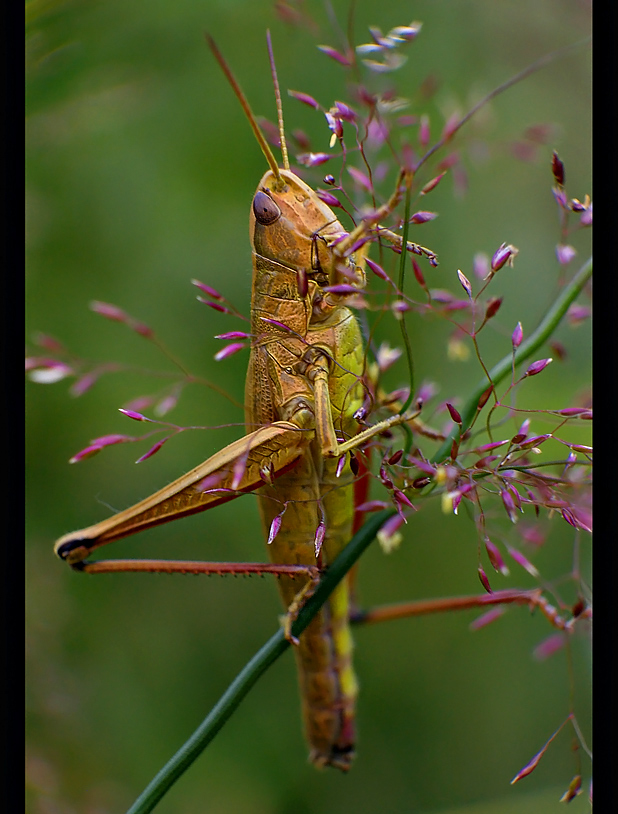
[27,0,591,814]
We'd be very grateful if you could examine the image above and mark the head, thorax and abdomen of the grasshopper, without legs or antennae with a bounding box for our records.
[245,170,364,770]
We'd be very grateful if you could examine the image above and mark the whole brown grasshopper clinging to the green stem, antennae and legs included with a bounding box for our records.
[55,33,428,771]
